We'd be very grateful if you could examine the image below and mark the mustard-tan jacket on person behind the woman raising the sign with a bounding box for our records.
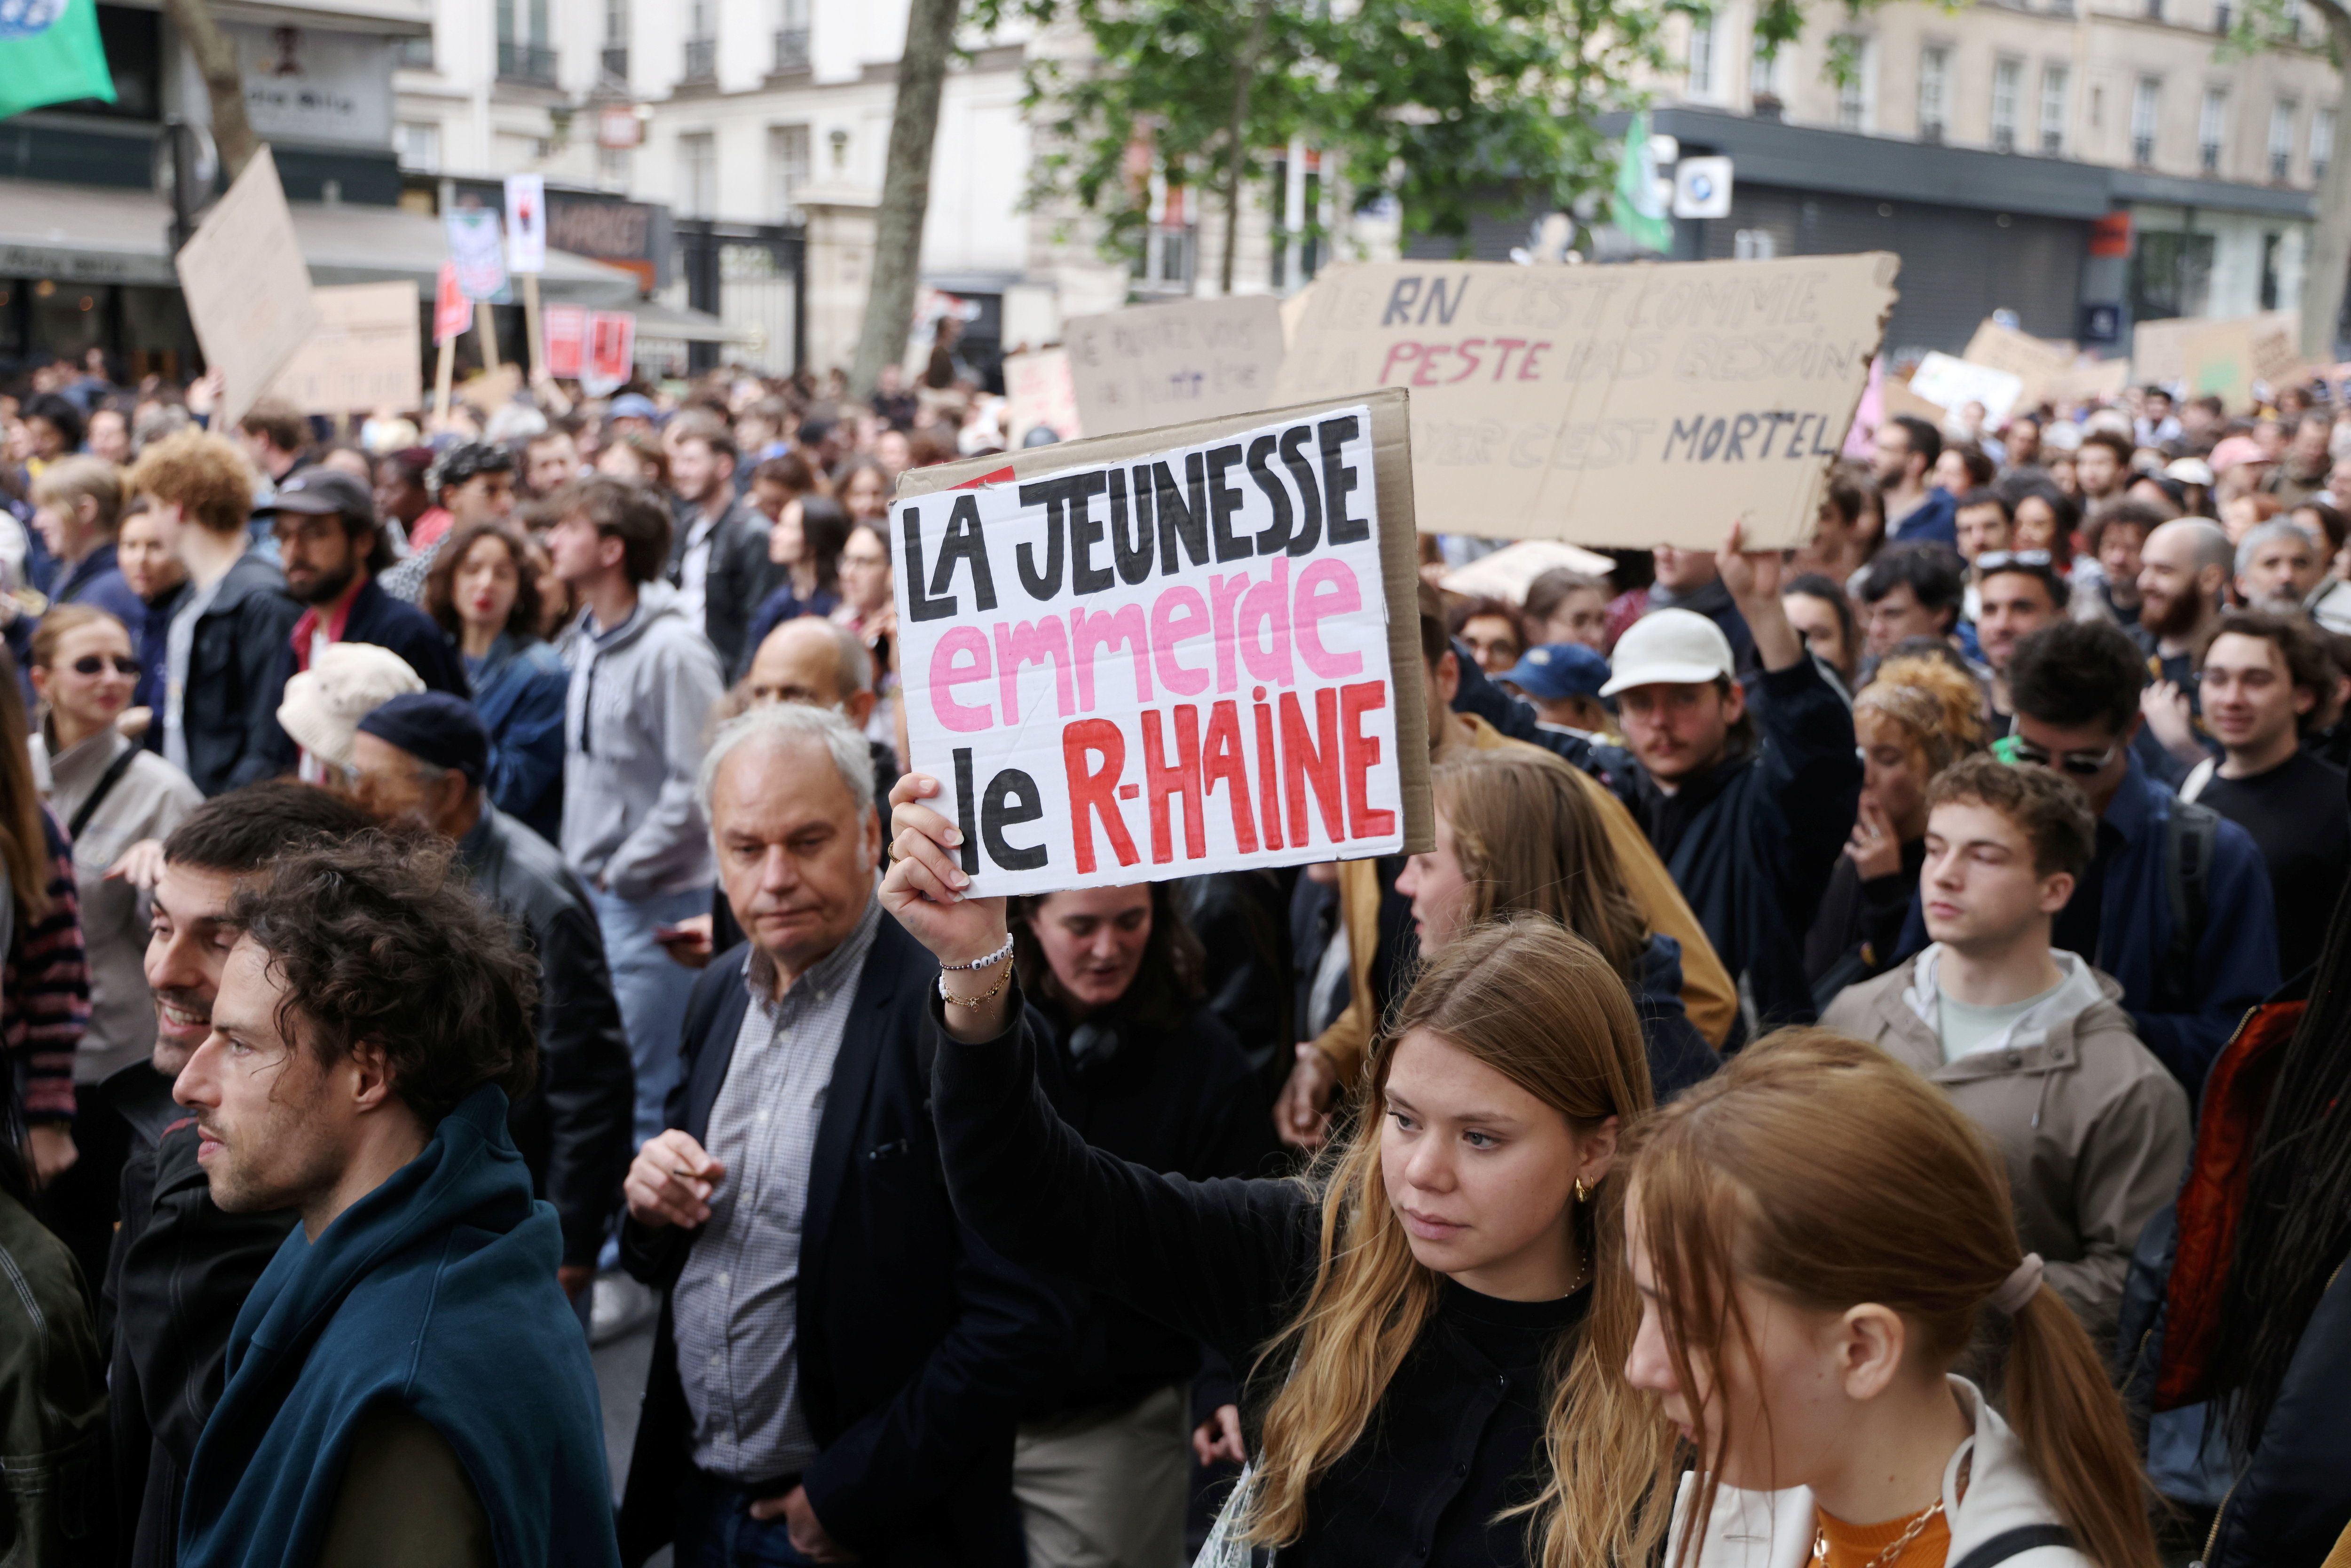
[1314,712,1740,1084]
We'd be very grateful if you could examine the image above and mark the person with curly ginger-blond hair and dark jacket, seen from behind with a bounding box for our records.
[122,430,301,795]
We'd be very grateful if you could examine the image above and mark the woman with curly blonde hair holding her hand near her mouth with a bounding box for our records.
[1803,654,1984,1006]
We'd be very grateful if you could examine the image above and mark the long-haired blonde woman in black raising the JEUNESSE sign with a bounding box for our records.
[882,773,1672,1568]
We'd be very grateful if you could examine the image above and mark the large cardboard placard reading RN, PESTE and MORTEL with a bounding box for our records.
[1277,252,1900,550]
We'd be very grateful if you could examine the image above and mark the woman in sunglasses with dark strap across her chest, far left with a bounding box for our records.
[31,604,205,1279]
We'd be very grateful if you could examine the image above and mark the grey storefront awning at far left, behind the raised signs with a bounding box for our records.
[0,179,743,343]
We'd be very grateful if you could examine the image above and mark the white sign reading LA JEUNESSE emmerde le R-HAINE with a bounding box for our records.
[891,390,1434,896]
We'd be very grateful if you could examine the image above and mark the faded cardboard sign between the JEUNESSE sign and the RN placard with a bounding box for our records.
[1060,294,1281,435]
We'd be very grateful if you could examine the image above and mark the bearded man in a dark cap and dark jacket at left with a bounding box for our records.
[254,468,470,771]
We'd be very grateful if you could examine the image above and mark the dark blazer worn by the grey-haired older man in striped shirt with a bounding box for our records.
[621,919,1070,1568]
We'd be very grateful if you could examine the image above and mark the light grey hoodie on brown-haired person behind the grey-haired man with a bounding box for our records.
[564,583,724,898]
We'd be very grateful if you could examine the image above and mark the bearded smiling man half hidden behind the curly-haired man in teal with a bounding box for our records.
[103,785,369,1568]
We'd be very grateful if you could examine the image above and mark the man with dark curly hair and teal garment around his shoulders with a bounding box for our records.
[172,835,618,1568]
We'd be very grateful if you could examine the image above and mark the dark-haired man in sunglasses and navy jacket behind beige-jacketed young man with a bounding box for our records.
[1902,621,2278,1095]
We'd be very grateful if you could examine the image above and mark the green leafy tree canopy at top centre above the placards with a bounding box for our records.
[976,0,1721,292]
